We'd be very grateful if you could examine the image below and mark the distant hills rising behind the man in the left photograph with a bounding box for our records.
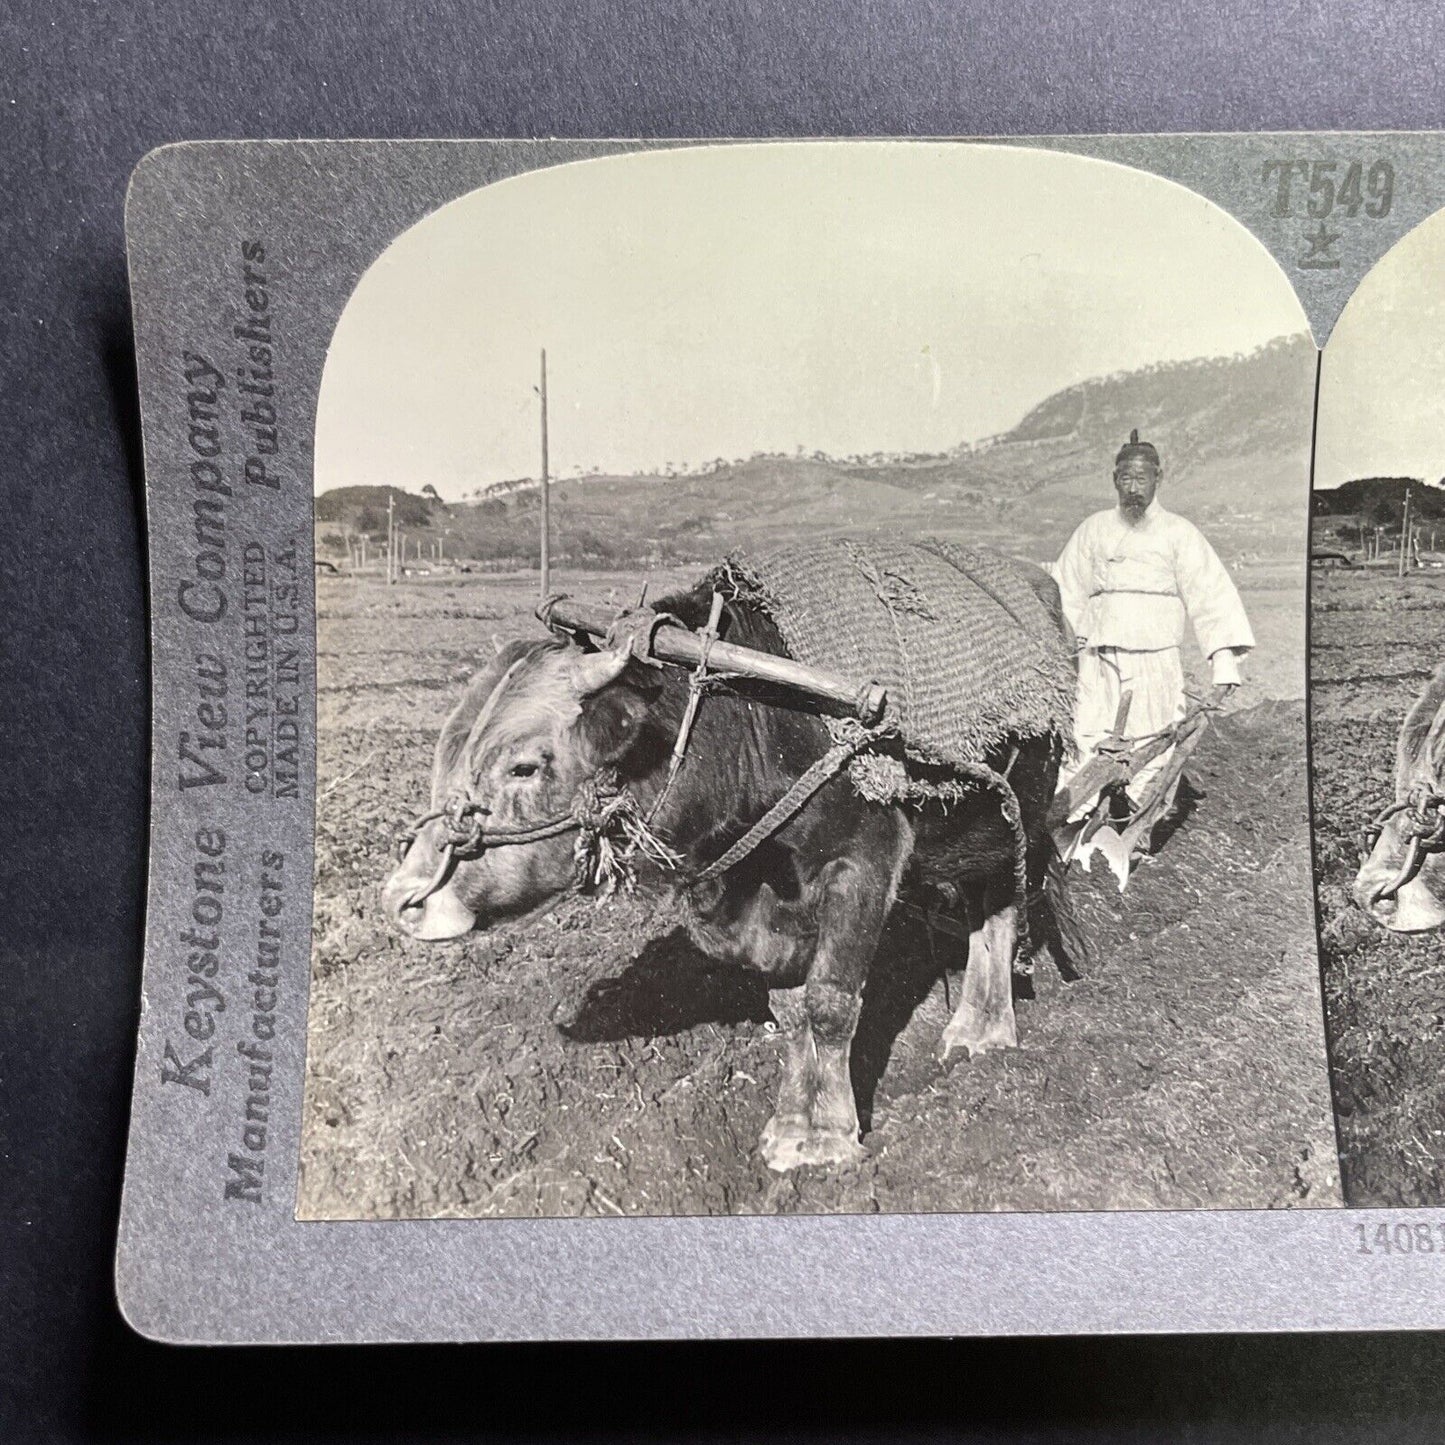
[316,337,1315,569]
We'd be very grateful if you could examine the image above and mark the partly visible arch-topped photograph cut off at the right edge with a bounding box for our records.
[1309,212,1445,1205]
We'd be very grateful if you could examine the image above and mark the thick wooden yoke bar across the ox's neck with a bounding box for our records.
[538,597,889,727]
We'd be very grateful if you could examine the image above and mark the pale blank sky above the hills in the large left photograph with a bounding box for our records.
[315,142,1305,500]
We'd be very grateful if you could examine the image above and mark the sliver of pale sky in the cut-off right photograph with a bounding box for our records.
[1315,212,1445,487]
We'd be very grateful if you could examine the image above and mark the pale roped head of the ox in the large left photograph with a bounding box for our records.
[381,642,649,939]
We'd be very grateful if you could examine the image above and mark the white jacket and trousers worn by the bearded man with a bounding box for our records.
[1053,501,1254,798]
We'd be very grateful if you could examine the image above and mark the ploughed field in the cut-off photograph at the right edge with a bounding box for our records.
[1311,569,1445,1205]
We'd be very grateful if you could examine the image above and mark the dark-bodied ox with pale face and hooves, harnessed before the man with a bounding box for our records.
[383,571,1079,1170]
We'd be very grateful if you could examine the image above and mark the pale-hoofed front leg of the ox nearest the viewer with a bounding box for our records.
[760,847,907,1172]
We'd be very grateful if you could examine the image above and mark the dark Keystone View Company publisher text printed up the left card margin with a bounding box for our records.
[158,237,305,1204]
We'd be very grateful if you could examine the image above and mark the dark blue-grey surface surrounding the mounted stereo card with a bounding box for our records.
[8,0,1445,1442]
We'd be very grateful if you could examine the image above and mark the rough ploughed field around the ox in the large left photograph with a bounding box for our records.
[298,564,1340,1218]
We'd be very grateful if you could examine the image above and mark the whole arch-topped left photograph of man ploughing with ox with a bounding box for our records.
[299,146,1338,1218]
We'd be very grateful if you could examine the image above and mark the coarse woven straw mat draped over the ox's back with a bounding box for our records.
[711,538,1075,766]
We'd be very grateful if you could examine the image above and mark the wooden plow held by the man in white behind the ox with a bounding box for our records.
[1048,692,1218,892]
